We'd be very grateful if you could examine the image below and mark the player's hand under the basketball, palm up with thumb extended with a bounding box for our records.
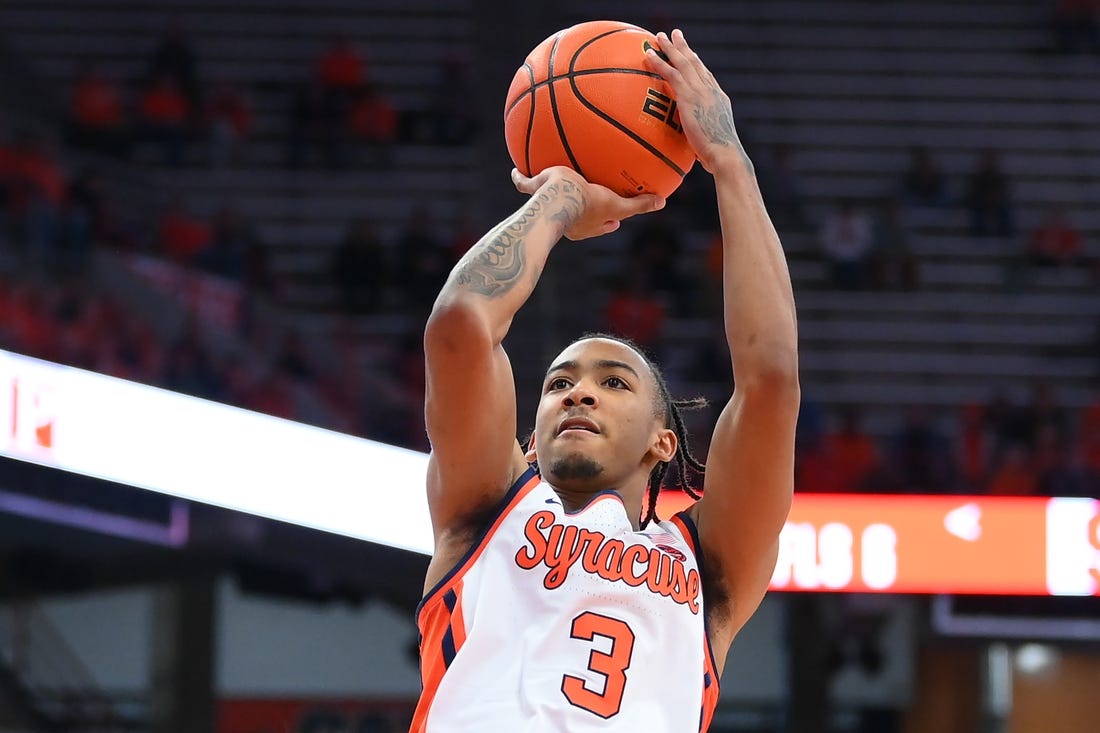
[512,165,664,241]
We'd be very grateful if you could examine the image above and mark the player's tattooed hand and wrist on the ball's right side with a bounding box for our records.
[646,29,751,174]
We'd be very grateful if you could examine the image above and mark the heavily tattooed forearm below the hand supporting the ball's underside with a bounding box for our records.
[432,178,581,343]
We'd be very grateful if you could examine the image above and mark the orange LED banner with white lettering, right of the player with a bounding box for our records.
[660,493,1100,595]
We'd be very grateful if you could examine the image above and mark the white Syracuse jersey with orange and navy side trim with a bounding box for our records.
[411,470,718,733]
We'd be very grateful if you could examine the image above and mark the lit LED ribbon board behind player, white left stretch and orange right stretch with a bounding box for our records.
[0,351,1100,595]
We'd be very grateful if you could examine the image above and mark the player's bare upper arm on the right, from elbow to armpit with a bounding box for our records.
[695,381,800,631]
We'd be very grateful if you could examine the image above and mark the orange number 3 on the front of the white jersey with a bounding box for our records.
[561,611,634,718]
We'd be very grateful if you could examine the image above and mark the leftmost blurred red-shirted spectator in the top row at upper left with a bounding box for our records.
[69,65,130,156]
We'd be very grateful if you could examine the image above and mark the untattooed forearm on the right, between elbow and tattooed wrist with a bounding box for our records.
[714,154,799,385]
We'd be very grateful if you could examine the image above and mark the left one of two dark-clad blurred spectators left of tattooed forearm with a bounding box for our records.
[330,214,391,316]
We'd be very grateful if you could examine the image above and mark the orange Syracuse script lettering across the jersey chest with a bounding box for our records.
[516,511,700,614]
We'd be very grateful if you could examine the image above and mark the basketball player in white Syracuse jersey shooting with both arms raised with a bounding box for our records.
[413,31,799,733]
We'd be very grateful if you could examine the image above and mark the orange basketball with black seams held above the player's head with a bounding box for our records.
[504,21,695,197]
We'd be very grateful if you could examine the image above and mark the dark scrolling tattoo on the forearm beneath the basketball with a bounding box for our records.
[455,180,581,298]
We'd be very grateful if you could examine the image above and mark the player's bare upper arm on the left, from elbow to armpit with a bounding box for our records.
[425,314,523,533]
